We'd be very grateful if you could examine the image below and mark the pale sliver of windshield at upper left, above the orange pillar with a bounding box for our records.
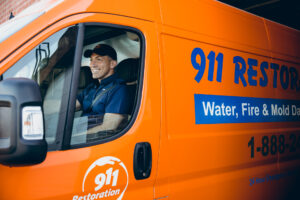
[0,12,45,43]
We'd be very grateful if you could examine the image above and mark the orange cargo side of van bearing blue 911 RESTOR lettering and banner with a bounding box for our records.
[155,0,300,199]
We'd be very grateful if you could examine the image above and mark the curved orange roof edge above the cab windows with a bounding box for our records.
[0,0,160,63]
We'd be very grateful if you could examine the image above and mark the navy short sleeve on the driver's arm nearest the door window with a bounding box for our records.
[105,85,130,114]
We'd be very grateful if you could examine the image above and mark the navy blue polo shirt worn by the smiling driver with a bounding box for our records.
[77,74,130,116]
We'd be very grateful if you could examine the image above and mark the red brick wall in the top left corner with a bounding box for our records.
[0,0,40,24]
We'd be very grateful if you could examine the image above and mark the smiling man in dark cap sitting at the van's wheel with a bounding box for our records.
[76,44,130,134]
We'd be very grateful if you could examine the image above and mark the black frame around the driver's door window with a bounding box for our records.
[61,22,146,150]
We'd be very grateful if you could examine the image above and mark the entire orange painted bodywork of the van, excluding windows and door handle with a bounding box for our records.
[0,0,300,200]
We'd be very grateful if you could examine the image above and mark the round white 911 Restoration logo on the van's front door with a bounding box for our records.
[73,156,128,200]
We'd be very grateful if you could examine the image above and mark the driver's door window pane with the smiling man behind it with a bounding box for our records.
[71,25,141,145]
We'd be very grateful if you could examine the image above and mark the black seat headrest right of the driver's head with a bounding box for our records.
[115,58,140,83]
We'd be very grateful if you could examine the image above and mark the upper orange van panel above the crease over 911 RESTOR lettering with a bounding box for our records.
[161,0,269,53]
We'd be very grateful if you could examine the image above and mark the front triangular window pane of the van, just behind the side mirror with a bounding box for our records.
[3,26,77,144]
